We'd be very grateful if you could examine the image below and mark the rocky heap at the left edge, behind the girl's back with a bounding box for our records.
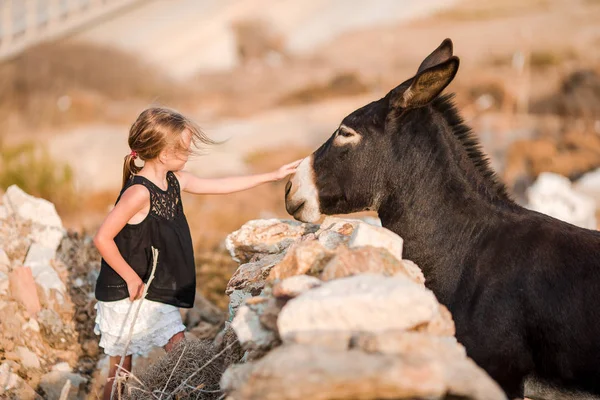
[0,186,94,399]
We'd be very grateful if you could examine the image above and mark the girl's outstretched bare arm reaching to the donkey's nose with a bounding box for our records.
[177,160,302,194]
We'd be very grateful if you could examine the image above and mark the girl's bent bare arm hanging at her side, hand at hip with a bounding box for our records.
[94,185,150,300]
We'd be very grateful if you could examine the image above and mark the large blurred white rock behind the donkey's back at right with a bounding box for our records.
[527,172,597,229]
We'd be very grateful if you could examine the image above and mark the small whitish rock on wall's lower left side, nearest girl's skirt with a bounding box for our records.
[231,305,277,356]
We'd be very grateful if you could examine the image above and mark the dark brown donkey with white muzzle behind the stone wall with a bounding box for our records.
[285,39,600,398]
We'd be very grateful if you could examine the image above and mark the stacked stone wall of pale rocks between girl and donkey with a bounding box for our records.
[221,217,505,400]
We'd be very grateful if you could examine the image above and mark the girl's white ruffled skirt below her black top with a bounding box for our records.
[94,299,185,356]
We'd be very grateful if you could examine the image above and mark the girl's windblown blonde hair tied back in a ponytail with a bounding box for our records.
[123,107,218,187]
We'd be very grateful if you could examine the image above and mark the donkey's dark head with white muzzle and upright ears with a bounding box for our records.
[285,39,459,222]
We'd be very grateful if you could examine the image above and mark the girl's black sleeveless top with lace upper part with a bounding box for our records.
[96,172,196,308]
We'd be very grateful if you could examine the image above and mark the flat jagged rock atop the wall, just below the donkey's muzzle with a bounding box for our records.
[225,219,318,263]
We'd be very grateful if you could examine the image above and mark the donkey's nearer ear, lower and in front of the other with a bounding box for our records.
[390,56,459,108]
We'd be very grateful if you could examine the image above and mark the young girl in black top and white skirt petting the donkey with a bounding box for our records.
[94,108,301,399]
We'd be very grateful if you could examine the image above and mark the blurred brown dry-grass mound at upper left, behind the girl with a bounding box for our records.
[0,43,186,133]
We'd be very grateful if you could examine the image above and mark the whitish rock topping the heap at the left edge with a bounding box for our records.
[3,185,65,250]
